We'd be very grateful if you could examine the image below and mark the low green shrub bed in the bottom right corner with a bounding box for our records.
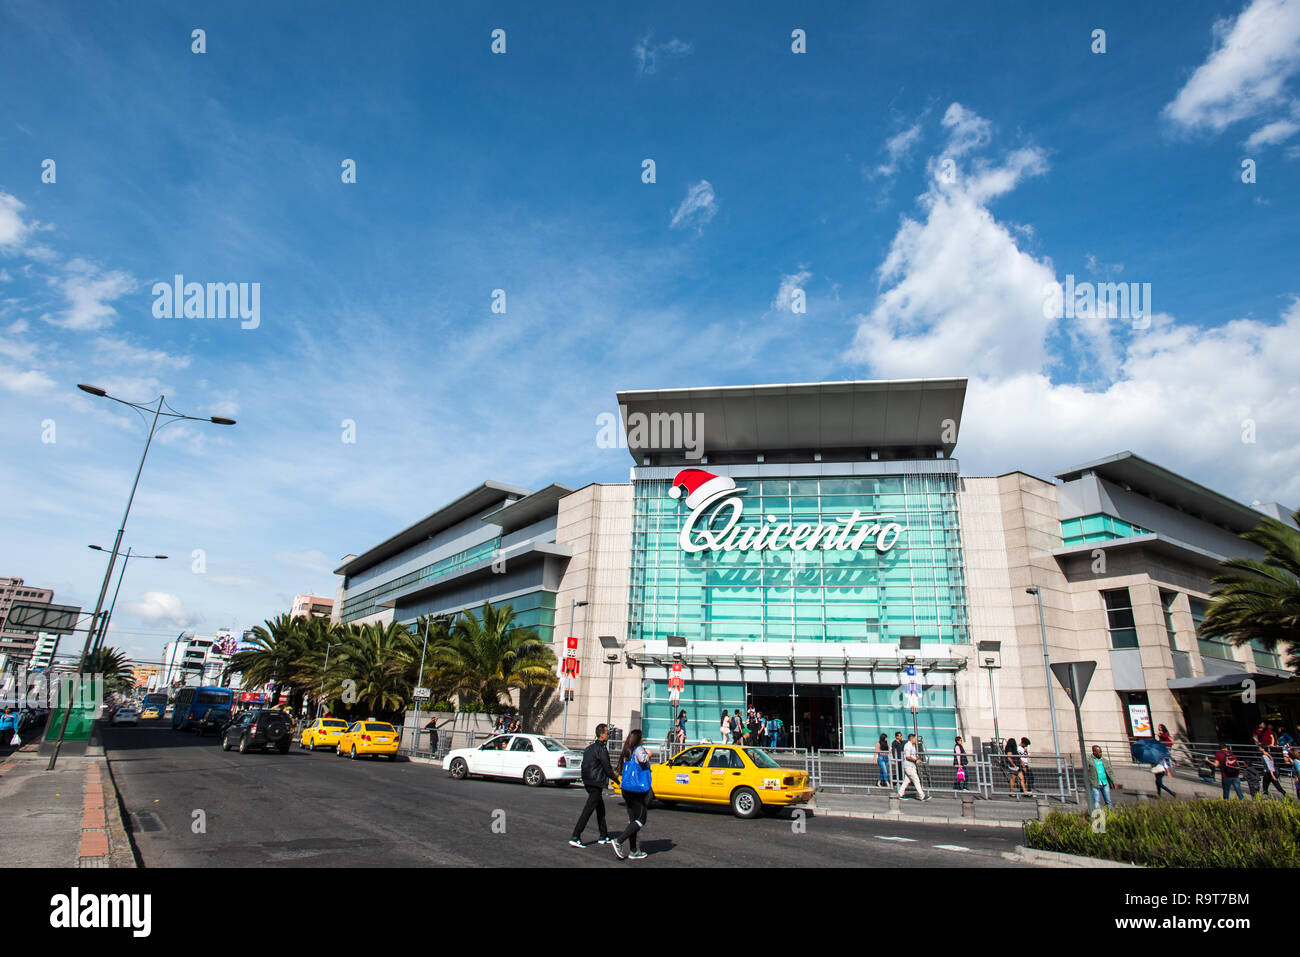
[1024,798,1300,867]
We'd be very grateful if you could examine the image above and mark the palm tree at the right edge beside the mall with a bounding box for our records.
[1200,511,1300,674]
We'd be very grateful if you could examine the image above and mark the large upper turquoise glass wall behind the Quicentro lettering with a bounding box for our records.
[628,475,969,644]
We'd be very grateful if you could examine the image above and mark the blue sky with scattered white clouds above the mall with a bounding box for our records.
[0,0,1300,657]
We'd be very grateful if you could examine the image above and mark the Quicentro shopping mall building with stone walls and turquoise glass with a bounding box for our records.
[335,378,1300,753]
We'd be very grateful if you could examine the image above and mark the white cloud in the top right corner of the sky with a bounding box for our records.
[1165,0,1300,133]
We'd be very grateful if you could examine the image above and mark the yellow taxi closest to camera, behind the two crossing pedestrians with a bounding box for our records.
[615,744,814,818]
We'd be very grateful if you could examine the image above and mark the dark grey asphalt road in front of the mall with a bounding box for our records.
[104,722,1023,867]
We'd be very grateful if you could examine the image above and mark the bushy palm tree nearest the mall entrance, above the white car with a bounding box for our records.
[433,602,558,705]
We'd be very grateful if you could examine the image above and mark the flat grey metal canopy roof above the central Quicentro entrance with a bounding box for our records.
[618,378,966,459]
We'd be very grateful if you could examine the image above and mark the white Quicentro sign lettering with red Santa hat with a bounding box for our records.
[668,468,906,554]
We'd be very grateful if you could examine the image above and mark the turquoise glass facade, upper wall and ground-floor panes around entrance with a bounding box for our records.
[628,473,970,750]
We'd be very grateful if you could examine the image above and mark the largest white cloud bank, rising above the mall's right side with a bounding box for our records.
[852,104,1300,506]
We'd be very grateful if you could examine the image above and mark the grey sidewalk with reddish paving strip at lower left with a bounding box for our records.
[0,741,135,867]
